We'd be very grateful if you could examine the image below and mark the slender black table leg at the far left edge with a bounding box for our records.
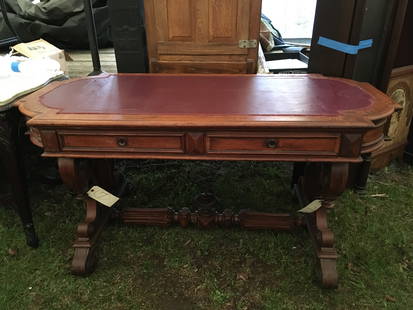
[0,111,39,248]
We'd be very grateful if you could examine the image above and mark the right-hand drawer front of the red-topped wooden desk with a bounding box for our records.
[207,133,340,155]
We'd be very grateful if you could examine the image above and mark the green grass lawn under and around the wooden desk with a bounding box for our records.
[0,161,413,310]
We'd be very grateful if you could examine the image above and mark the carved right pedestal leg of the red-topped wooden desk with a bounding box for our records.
[299,163,349,288]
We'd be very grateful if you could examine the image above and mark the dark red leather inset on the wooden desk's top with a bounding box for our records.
[40,75,373,115]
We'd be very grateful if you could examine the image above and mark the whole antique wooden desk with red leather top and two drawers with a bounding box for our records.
[19,74,395,287]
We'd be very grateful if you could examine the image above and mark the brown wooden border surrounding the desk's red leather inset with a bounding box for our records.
[16,73,398,128]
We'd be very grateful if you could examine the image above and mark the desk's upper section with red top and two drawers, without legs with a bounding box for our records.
[19,74,396,162]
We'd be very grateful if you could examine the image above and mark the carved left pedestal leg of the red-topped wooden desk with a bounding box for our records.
[58,158,114,275]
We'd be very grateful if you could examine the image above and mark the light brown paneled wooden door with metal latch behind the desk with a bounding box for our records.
[144,0,261,73]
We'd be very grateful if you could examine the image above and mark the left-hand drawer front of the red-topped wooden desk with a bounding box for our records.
[58,132,184,153]
